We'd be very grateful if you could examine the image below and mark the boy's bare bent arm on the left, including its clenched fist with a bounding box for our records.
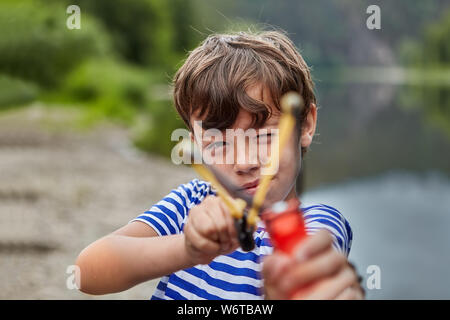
[76,192,239,294]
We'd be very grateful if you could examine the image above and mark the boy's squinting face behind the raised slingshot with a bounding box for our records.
[191,86,316,205]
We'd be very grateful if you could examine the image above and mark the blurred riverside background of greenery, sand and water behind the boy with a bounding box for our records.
[0,0,450,299]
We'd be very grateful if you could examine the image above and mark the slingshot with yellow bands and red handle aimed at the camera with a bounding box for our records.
[181,92,306,254]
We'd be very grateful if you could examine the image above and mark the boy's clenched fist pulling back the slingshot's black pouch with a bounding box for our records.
[184,196,239,265]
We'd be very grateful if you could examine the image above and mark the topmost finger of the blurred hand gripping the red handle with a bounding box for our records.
[294,229,333,262]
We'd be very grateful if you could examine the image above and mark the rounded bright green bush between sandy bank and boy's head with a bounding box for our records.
[57,59,183,156]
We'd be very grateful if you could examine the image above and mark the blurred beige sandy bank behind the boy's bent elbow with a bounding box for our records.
[0,105,194,299]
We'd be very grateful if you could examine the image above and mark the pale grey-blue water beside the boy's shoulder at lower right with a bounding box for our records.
[302,171,450,299]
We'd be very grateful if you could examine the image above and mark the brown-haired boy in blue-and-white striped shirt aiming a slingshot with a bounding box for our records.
[77,31,363,299]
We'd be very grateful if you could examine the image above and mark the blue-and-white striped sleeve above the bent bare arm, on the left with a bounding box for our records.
[129,179,212,236]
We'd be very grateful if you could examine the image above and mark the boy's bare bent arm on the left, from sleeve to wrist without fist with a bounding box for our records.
[76,221,194,294]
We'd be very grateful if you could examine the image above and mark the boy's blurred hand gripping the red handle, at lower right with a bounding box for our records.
[262,230,364,300]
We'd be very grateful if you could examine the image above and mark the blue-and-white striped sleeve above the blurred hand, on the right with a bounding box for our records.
[302,204,353,256]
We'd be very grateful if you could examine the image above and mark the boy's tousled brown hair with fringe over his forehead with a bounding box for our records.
[173,31,316,151]
